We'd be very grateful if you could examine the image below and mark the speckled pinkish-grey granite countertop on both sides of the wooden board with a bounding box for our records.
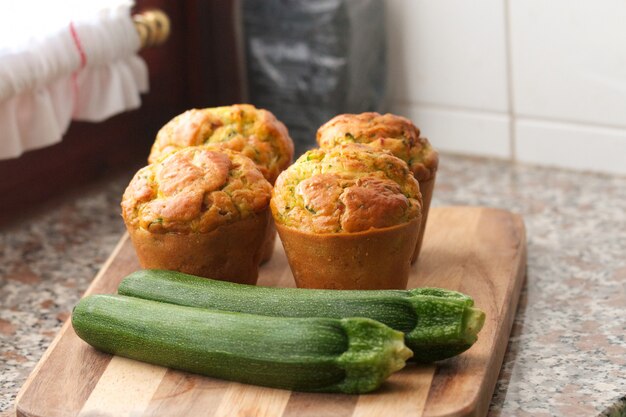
[0,155,626,417]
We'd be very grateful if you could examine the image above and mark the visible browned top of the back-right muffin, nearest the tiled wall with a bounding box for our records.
[317,112,439,181]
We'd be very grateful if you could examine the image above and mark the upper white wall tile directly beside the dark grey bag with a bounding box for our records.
[386,0,508,112]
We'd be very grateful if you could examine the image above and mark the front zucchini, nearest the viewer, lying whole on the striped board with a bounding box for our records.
[72,295,411,394]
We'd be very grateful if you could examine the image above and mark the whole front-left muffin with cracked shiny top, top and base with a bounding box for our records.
[121,147,272,284]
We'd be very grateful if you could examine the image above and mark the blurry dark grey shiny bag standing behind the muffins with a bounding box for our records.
[241,0,386,154]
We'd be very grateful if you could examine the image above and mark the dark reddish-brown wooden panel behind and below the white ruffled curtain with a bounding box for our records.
[0,0,243,222]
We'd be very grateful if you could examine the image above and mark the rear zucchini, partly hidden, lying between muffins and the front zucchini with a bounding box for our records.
[118,270,485,363]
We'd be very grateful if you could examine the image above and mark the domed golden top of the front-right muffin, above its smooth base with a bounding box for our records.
[271,144,422,234]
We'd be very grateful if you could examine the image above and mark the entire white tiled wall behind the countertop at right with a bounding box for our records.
[386,0,626,174]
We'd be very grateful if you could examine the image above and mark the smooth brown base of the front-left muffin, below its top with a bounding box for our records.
[128,209,270,285]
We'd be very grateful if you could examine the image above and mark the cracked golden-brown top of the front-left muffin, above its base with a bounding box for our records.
[122,147,272,233]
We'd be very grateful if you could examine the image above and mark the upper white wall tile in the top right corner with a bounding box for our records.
[510,0,626,127]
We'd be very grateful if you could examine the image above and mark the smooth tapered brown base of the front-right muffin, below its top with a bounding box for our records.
[276,218,420,290]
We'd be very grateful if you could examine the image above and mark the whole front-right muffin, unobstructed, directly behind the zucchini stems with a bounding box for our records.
[271,144,421,289]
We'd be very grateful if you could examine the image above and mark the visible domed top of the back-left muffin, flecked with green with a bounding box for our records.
[148,104,293,183]
